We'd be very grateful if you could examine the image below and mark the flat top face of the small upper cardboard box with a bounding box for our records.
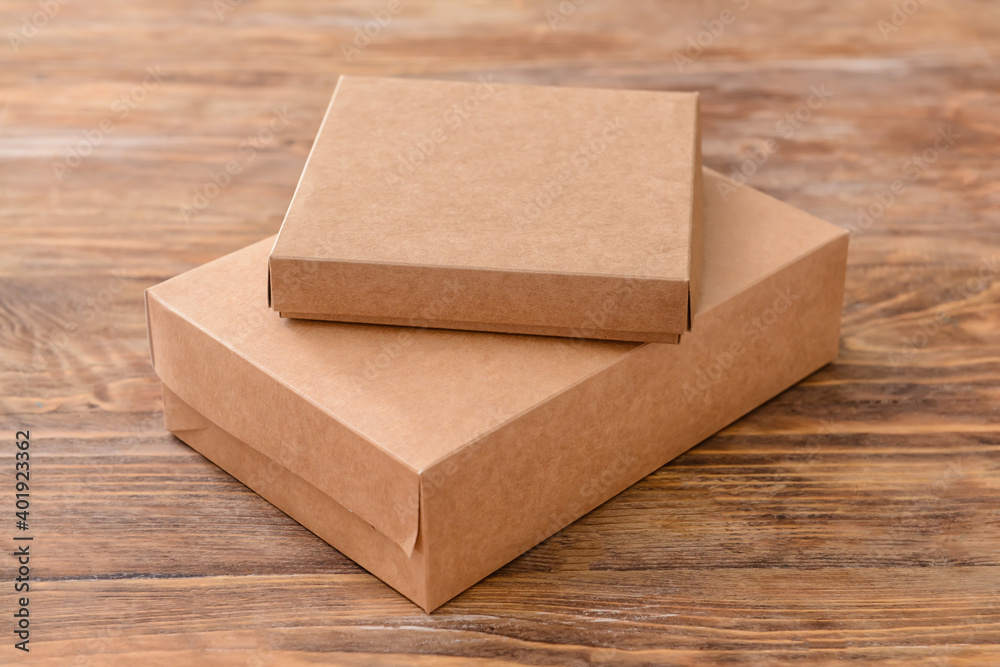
[274,76,697,280]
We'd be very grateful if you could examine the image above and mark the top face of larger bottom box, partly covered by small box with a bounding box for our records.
[149,170,844,471]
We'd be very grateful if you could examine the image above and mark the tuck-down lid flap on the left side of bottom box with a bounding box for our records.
[147,294,419,552]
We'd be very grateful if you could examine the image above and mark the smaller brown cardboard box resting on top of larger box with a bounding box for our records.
[268,76,702,342]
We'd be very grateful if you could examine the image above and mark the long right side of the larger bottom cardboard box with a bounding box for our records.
[421,236,847,607]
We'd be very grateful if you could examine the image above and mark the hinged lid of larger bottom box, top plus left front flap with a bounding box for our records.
[147,171,844,568]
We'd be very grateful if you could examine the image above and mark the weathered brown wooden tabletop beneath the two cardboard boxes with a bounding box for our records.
[0,0,1000,665]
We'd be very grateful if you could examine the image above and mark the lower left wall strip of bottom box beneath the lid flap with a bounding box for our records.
[163,385,427,608]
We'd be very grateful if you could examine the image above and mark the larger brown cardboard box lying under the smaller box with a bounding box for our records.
[147,171,847,610]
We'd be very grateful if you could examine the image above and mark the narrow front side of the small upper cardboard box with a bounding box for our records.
[270,255,689,340]
